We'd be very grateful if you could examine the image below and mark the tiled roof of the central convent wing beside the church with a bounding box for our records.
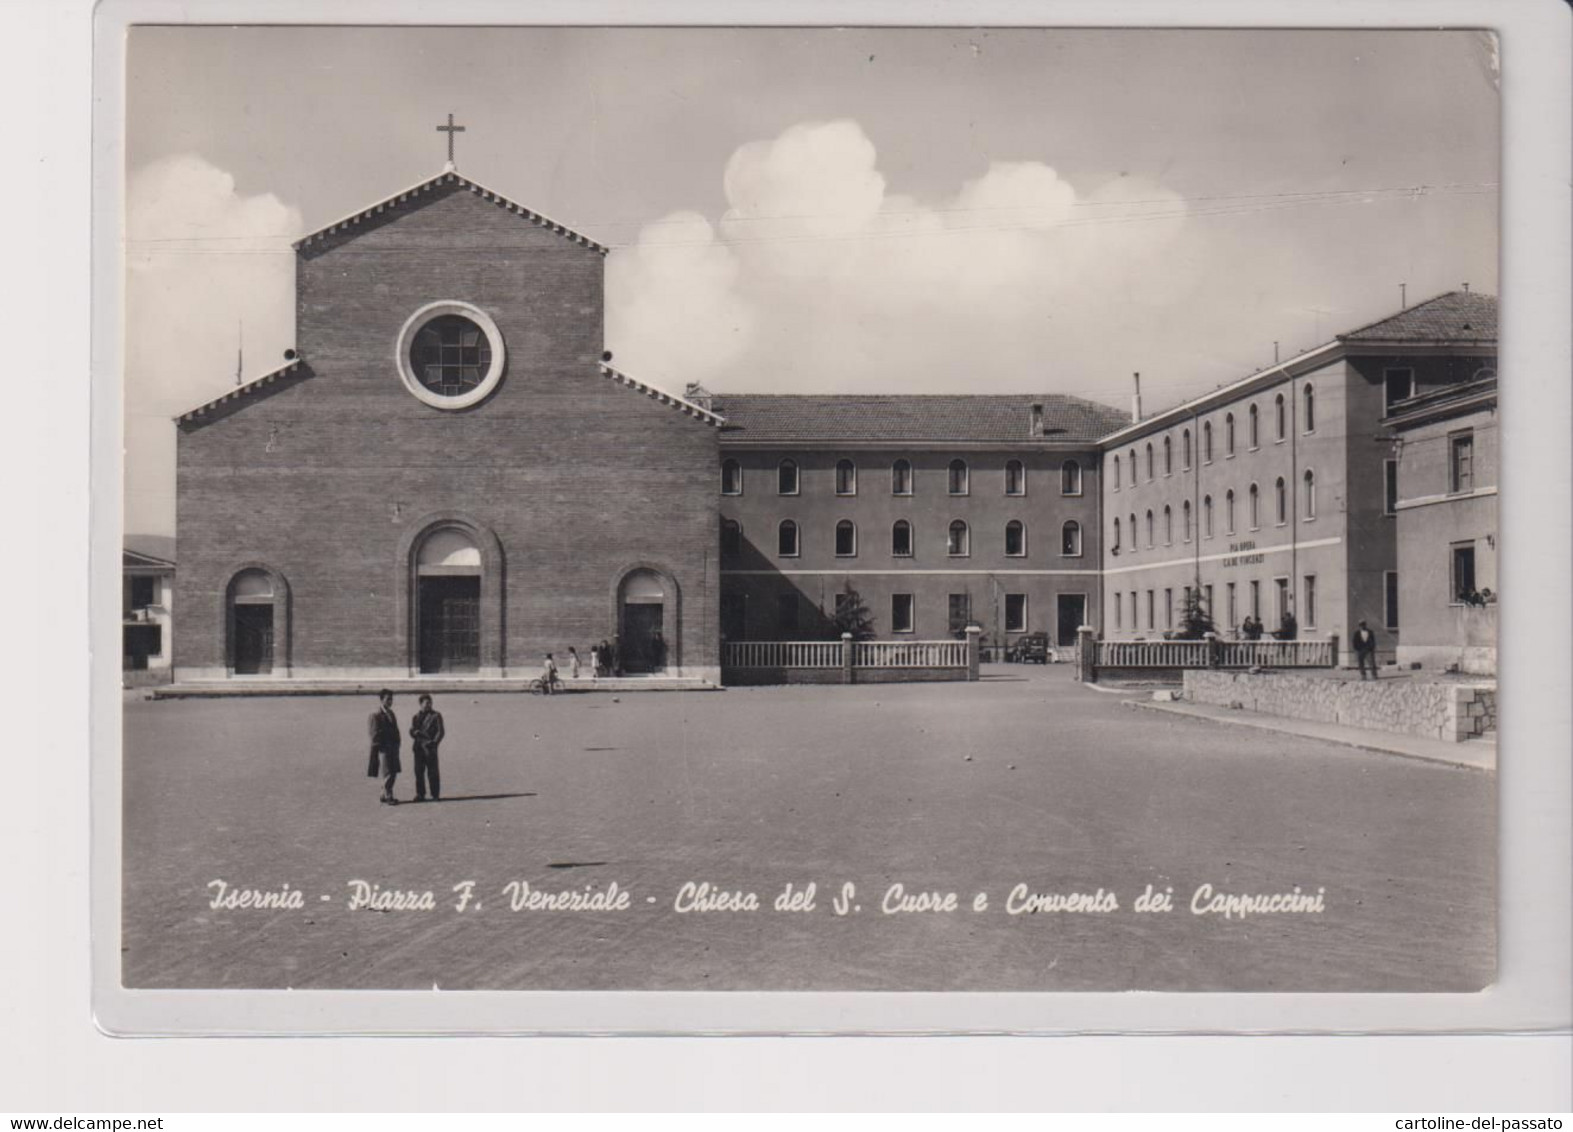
[714,393,1131,443]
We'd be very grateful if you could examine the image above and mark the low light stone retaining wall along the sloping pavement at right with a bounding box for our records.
[1184,668,1496,742]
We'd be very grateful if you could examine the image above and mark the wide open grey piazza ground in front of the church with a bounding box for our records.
[123,667,1496,991]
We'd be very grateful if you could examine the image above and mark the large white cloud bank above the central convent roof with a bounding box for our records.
[607,121,1186,391]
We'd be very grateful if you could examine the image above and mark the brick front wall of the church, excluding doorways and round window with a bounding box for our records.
[175,184,719,676]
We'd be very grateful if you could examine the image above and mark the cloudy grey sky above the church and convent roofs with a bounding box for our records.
[124,27,1499,535]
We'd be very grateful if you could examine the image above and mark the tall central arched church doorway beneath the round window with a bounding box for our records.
[415,527,481,673]
